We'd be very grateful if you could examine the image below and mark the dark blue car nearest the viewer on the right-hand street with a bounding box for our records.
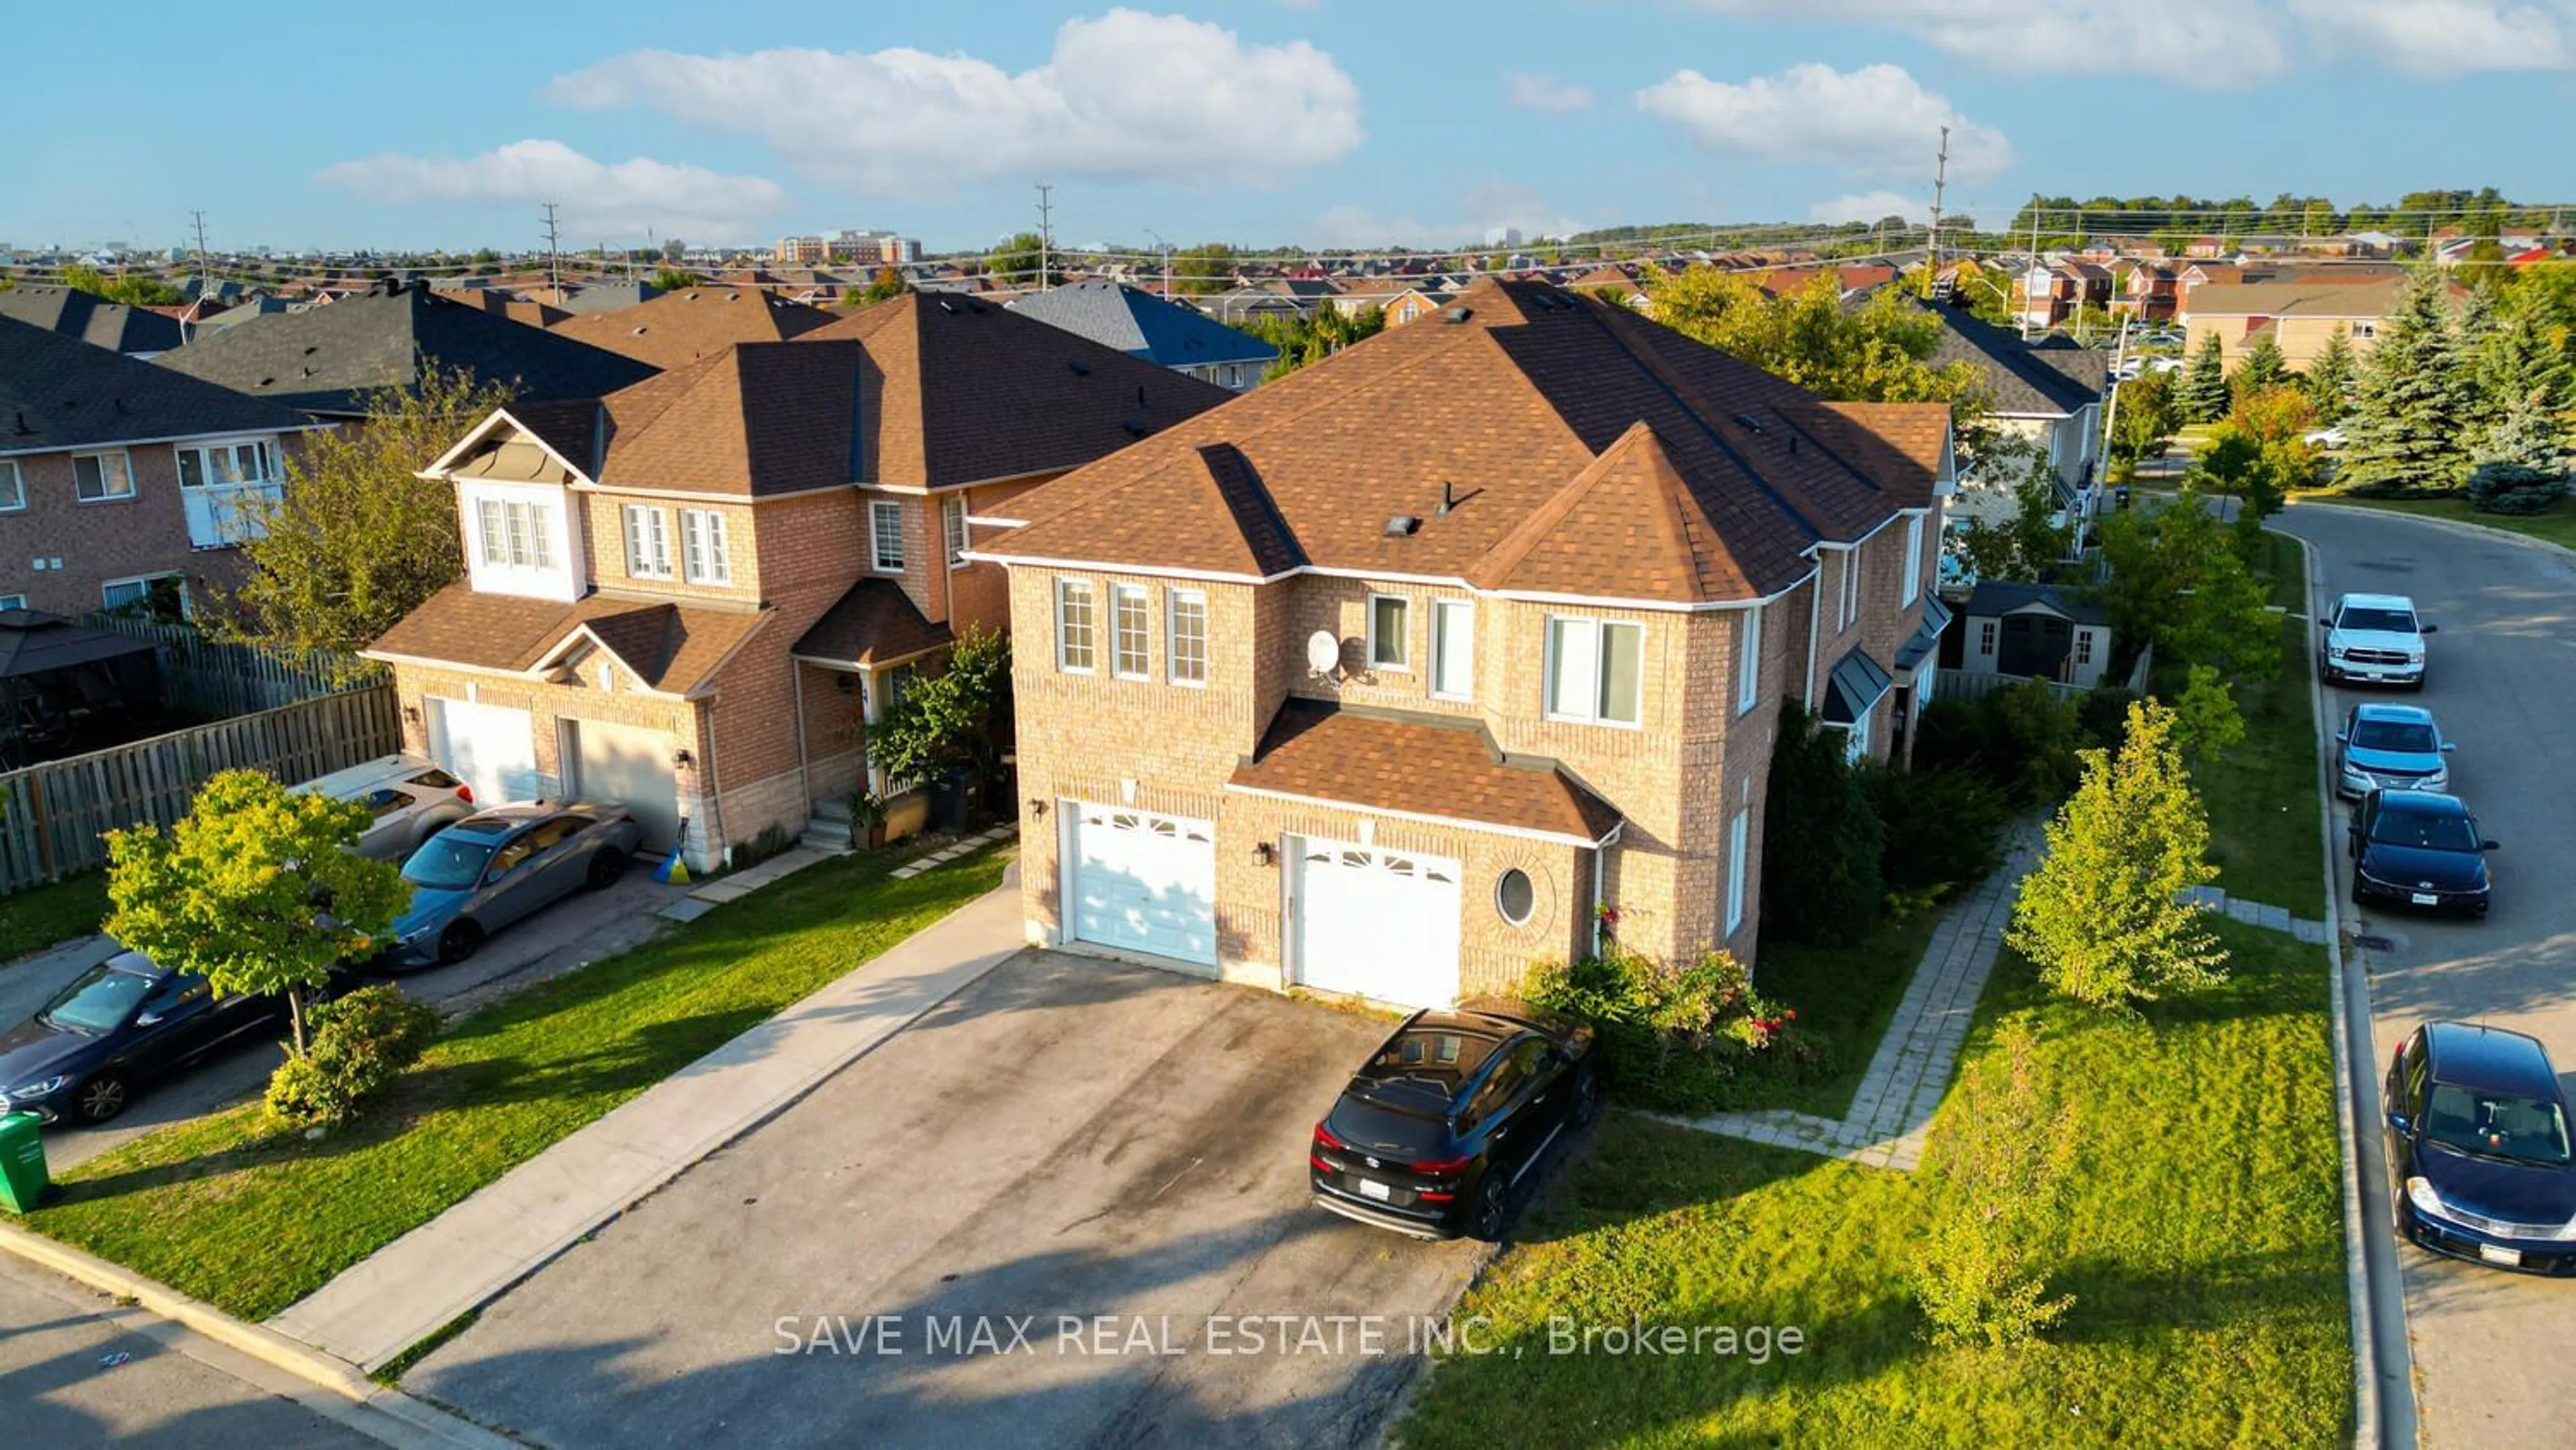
[2385,1023,2576,1275]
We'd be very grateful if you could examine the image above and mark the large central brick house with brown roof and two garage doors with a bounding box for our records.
[976,280,1953,1004]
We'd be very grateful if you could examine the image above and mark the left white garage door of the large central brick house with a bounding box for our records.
[1064,801,1216,966]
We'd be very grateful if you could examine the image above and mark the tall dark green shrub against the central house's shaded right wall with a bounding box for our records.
[1762,701,1886,943]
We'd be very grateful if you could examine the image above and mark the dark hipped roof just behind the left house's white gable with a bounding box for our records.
[154,283,654,420]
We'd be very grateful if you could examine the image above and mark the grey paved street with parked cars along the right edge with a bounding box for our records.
[2275,505,2576,1447]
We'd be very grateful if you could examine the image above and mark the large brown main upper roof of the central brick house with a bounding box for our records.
[984,280,1947,600]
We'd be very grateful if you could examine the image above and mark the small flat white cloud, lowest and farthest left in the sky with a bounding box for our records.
[314,139,786,245]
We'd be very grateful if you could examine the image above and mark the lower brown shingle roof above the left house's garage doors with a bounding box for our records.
[368,580,770,695]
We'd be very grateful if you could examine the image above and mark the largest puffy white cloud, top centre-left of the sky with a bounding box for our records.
[549,10,1362,191]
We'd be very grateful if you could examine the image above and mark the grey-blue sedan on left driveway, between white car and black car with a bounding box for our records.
[386,801,644,968]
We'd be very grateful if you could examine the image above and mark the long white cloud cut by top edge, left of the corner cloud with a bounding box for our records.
[1700,0,2298,90]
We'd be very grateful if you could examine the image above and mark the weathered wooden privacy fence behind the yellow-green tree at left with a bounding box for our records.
[0,685,402,894]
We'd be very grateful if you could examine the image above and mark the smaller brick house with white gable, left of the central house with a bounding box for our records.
[368,296,1232,870]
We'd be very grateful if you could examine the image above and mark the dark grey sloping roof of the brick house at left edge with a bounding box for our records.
[0,317,309,454]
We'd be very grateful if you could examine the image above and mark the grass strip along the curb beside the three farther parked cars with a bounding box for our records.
[2200,533,2326,919]
